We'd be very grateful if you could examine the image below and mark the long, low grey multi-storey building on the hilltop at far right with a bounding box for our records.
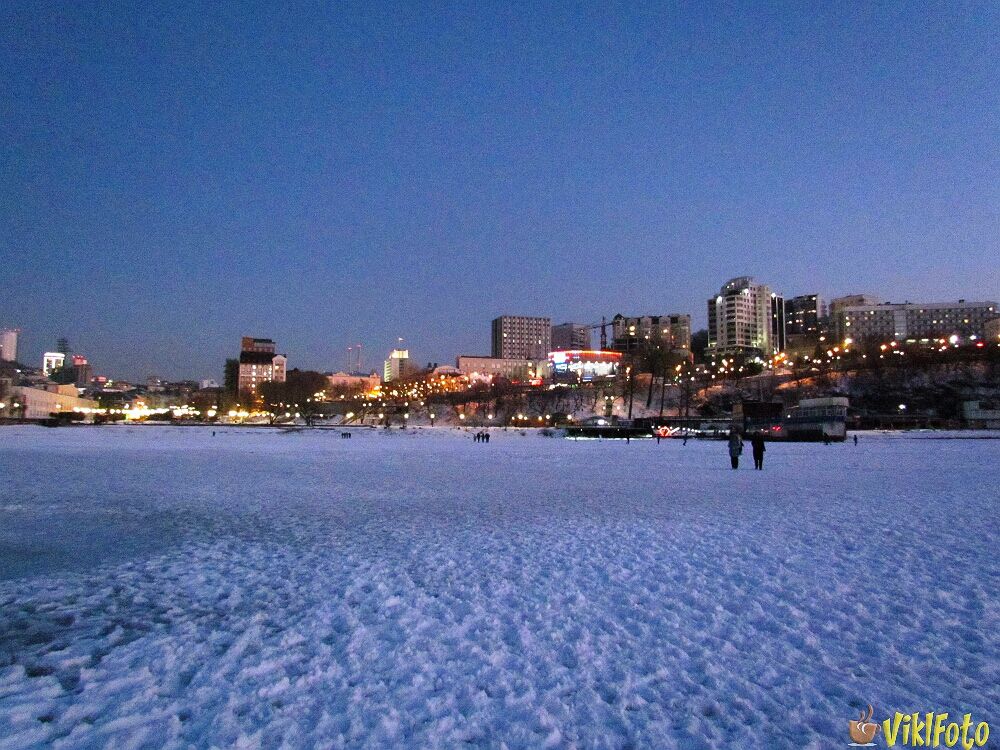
[833,299,1000,346]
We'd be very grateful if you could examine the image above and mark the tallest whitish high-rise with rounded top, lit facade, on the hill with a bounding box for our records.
[707,276,785,357]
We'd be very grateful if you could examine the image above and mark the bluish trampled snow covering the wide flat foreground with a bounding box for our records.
[0,427,1000,749]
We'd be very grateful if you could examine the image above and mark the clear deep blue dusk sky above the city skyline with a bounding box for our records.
[0,1,1000,379]
